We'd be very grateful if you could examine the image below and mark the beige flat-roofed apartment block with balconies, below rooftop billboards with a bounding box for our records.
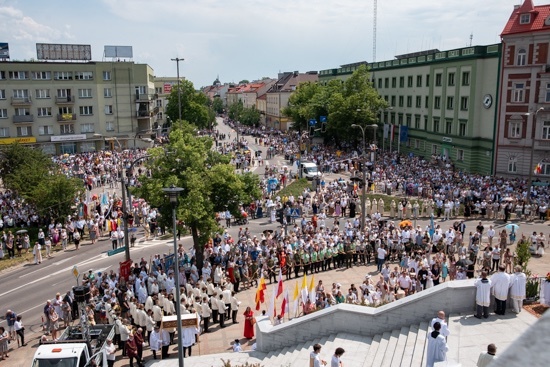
[0,61,154,154]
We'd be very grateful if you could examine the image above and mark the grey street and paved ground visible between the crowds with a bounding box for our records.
[0,118,550,366]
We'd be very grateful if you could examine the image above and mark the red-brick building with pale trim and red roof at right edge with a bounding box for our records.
[495,0,550,180]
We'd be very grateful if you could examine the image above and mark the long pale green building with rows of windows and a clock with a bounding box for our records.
[319,44,500,174]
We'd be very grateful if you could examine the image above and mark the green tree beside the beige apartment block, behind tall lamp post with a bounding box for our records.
[166,80,215,129]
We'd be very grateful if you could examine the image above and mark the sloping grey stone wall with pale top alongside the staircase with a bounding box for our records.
[256,280,476,353]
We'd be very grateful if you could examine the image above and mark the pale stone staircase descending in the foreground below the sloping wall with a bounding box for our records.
[147,322,438,367]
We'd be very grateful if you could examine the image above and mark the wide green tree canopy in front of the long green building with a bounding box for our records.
[282,65,388,144]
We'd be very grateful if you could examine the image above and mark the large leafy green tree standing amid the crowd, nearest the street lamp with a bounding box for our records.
[135,121,261,268]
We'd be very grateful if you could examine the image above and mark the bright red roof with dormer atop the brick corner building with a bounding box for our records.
[500,0,550,37]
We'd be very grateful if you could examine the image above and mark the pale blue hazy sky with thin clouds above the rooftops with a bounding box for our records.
[0,0,528,87]
